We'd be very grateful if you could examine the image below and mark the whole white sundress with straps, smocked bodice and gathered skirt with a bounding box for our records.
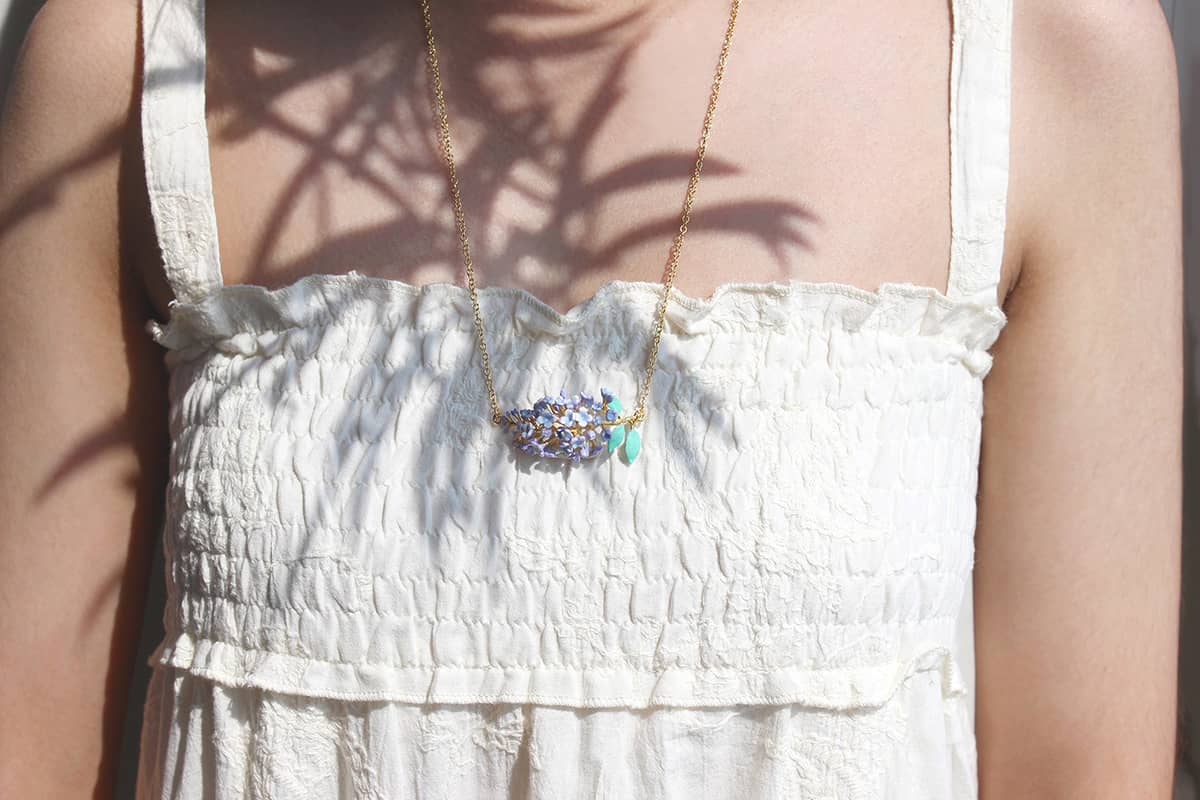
[137,0,1012,800]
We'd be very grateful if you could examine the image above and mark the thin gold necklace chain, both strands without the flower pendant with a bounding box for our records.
[421,0,739,427]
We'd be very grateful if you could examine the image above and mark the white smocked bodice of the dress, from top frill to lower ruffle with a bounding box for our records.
[142,273,1004,706]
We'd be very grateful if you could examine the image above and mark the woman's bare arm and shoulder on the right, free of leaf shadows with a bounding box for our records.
[974,0,1183,800]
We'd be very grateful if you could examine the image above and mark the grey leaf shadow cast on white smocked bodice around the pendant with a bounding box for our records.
[219,284,732,566]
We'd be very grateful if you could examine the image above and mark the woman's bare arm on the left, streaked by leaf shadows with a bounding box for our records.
[0,0,167,798]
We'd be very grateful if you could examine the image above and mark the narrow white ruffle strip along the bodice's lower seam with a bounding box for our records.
[149,632,967,710]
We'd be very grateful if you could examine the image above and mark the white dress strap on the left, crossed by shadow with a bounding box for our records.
[142,0,222,302]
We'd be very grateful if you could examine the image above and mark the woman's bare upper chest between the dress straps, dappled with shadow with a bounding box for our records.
[138,1,984,321]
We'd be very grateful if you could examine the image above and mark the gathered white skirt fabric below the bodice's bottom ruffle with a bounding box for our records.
[138,667,976,800]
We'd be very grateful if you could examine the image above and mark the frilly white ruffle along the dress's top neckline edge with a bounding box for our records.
[145,271,1008,374]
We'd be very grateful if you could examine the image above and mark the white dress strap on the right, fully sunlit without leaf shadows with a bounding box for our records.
[947,0,1013,306]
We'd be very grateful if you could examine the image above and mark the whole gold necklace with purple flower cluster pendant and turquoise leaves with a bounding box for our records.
[421,0,739,464]
